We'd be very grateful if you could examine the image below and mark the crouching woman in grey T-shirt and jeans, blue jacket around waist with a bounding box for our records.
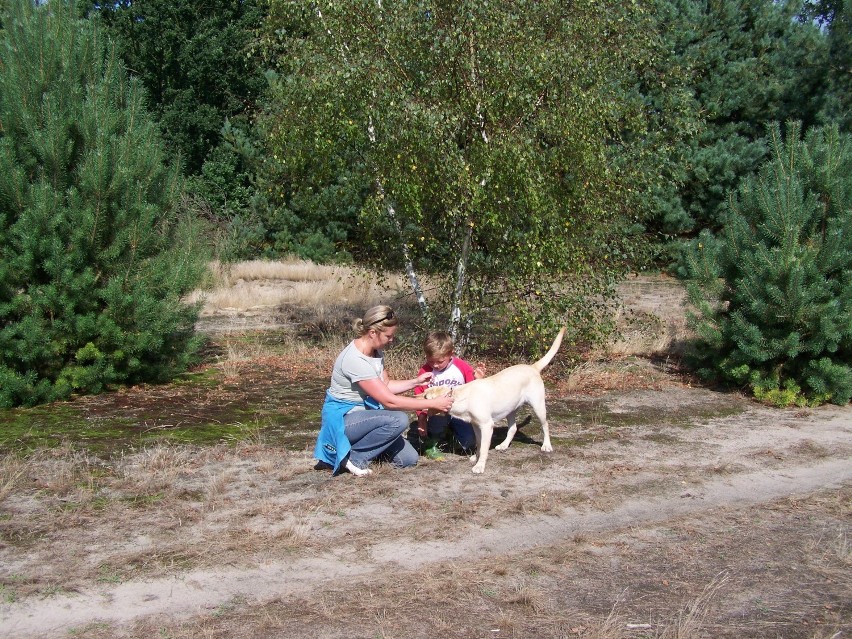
[314,306,453,476]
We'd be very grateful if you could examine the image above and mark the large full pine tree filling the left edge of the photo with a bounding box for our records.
[0,0,210,406]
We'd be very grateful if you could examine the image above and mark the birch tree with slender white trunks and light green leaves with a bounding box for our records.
[255,0,674,356]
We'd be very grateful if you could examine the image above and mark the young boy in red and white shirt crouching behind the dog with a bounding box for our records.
[410,331,485,460]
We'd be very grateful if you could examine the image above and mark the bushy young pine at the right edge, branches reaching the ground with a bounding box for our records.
[688,123,852,405]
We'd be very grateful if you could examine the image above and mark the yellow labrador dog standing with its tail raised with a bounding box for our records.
[423,328,565,474]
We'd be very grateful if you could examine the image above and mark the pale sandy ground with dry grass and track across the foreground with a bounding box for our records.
[0,276,852,639]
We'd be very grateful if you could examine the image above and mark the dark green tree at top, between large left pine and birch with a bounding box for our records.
[90,0,266,176]
